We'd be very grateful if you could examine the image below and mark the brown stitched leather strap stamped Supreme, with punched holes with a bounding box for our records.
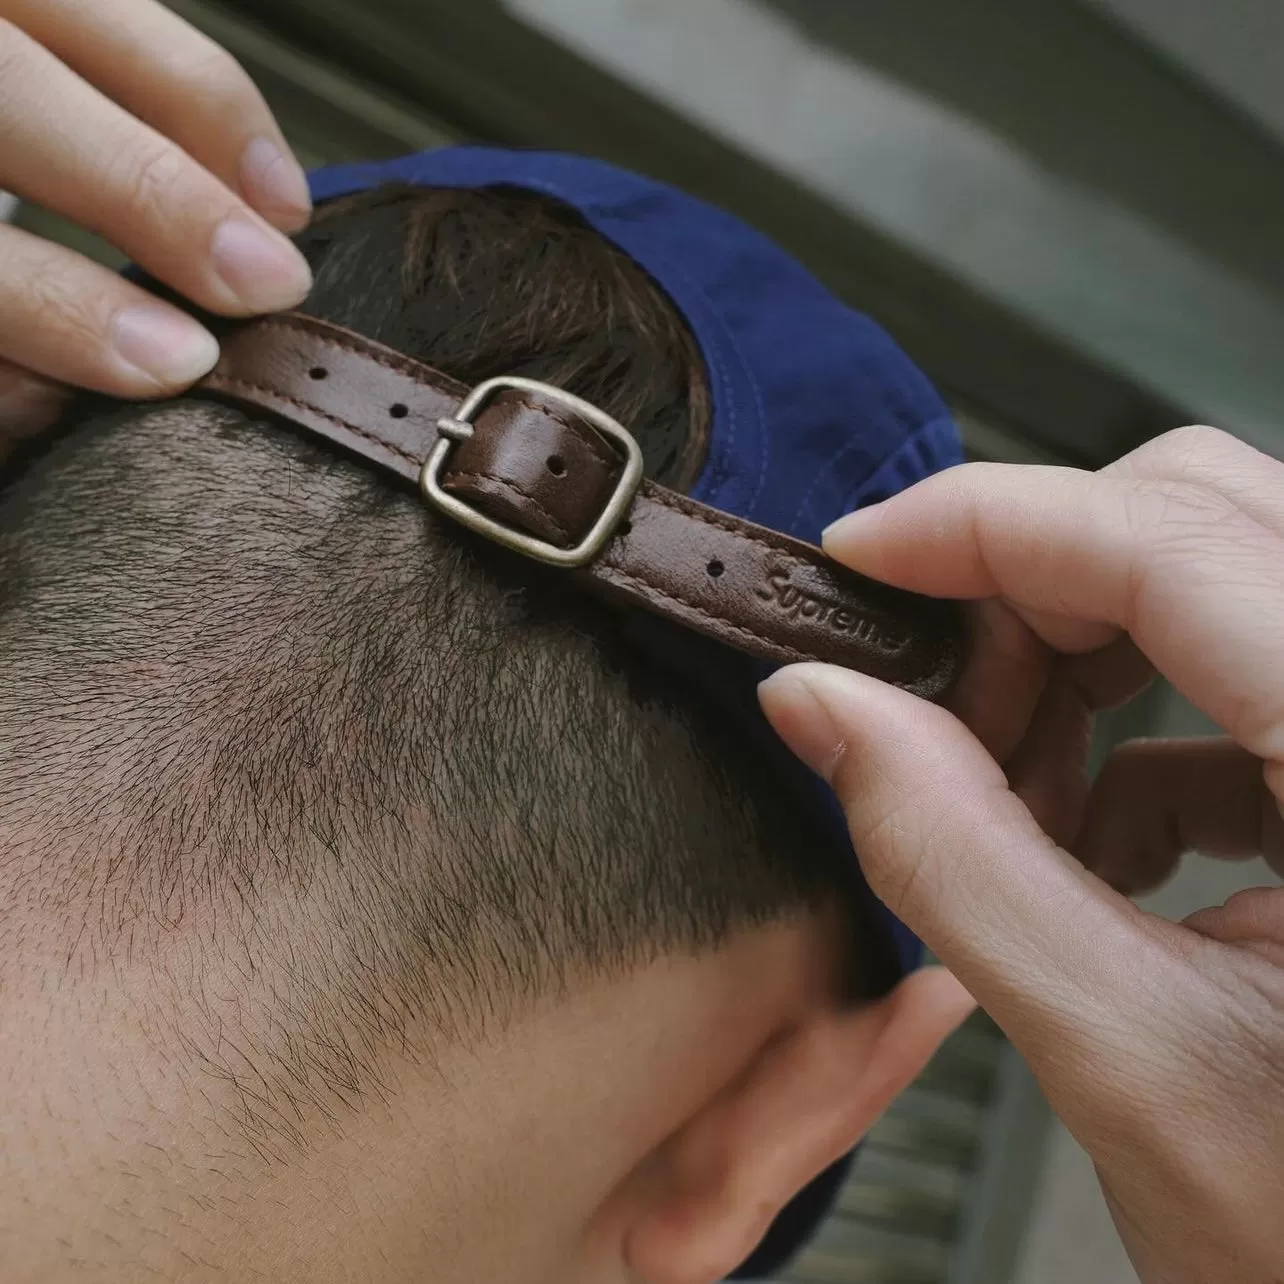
[199,313,962,697]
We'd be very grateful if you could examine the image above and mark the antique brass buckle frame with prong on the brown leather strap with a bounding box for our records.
[419,376,642,566]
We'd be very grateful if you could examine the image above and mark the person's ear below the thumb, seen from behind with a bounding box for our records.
[623,968,975,1284]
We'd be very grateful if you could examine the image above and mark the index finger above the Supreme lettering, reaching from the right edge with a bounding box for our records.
[827,464,1284,759]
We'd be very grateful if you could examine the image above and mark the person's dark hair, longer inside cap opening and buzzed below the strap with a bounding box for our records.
[0,187,890,1156]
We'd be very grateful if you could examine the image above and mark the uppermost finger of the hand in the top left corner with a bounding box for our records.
[4,0,311,231]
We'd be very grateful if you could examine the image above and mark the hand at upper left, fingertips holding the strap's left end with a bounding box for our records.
[0,0,311,448]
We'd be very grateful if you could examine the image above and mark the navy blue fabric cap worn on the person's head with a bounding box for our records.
[311,146,962,1279]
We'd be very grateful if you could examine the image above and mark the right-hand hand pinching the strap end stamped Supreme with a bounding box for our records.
[763,429,1284,1284]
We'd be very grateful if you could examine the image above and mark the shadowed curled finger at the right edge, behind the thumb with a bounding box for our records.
[1075,738,1284,892]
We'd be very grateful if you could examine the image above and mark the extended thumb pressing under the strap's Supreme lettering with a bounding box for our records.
[761,665,1163,1077]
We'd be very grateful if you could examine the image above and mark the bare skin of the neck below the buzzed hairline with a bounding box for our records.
[0,909,811,1284]
